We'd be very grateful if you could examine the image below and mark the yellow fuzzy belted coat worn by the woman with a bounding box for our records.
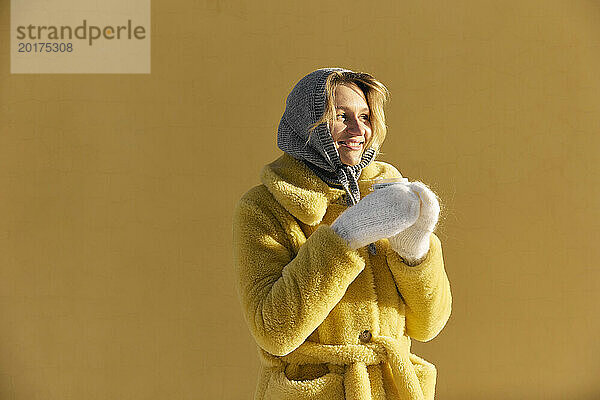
[233,153,451,400]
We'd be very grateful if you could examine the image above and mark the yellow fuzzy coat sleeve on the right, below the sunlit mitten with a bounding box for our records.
[386,233,452,342]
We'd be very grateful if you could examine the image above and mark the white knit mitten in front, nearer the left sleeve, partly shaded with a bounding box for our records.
[331,185,419,249]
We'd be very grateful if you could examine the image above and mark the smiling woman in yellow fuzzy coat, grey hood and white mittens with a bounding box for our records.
[234,68,451,400]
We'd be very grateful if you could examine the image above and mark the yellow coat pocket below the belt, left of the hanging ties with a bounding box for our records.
[264,369,344,400]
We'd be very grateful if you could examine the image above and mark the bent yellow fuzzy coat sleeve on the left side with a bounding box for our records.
[233,189,365,356]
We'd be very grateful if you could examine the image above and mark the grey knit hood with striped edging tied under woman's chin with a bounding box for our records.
[277,68,376,205]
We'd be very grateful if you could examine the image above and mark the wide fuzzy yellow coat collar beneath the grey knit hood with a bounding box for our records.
[261,153,400,225]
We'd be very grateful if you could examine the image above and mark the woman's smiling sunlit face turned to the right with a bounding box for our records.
[331,83,373,165]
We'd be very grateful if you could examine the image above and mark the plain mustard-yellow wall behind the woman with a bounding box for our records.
[0,0,600,400]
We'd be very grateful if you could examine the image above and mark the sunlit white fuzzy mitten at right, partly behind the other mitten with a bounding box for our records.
[389,182,440,266]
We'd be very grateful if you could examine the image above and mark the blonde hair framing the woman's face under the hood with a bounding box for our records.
[308,71,389,150]
